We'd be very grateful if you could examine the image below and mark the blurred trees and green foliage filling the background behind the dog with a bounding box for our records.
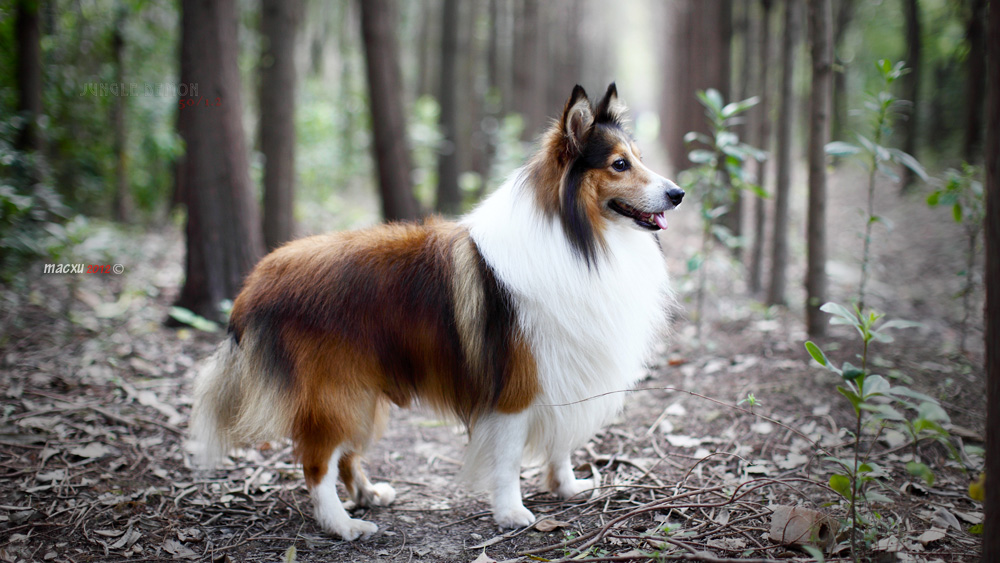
[0,0,987,318]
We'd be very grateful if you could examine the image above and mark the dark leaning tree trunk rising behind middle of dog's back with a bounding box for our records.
[359,0,420,221]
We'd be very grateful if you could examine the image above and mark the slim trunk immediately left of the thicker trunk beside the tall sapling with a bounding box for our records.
[767,0,799,305]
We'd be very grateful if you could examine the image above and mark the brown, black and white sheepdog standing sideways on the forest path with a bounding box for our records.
[191,84,684,540]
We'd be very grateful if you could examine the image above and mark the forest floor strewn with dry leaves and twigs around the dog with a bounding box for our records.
[0,172,986,563]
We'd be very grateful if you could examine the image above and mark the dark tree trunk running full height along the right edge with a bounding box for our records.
[982,3,1000,563]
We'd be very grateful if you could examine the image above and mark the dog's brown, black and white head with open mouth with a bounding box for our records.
[532,83,684,263]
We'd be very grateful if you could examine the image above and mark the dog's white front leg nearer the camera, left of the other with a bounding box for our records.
[471,412,535,528]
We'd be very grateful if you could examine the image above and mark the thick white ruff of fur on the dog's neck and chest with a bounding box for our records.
[465,175,672,462]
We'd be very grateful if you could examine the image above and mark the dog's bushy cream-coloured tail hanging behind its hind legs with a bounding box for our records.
[188,334,294,468]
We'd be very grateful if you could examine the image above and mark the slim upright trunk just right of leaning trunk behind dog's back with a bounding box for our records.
[437,0,462,215]
